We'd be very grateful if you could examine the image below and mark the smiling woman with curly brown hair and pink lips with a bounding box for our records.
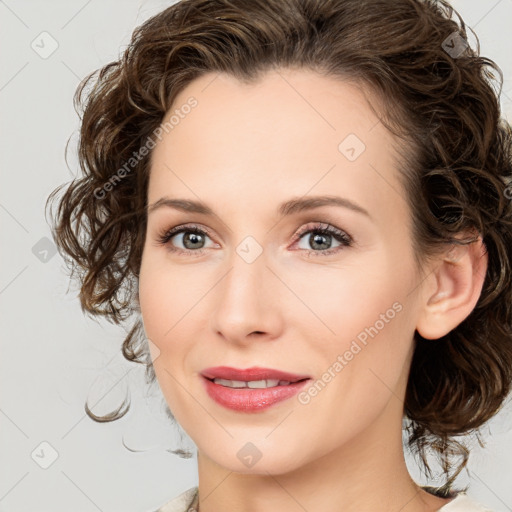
[45,0,512,512]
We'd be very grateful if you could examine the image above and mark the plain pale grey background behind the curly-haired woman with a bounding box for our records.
[0,0,512,512]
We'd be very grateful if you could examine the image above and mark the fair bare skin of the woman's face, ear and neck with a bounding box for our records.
[139,69,487,512]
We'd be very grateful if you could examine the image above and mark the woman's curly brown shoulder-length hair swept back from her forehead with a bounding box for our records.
[47,0,512,493]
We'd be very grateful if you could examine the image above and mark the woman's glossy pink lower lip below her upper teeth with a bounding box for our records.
[202,377,310,412]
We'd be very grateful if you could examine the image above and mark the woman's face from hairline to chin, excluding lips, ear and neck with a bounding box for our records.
[139,69,421,474]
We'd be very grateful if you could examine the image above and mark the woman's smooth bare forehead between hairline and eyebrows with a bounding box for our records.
[148,69,406,225]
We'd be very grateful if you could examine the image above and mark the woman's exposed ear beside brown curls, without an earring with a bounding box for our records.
[416,236,488,339]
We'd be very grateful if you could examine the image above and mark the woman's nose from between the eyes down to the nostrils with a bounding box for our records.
[210,254,282,344]
